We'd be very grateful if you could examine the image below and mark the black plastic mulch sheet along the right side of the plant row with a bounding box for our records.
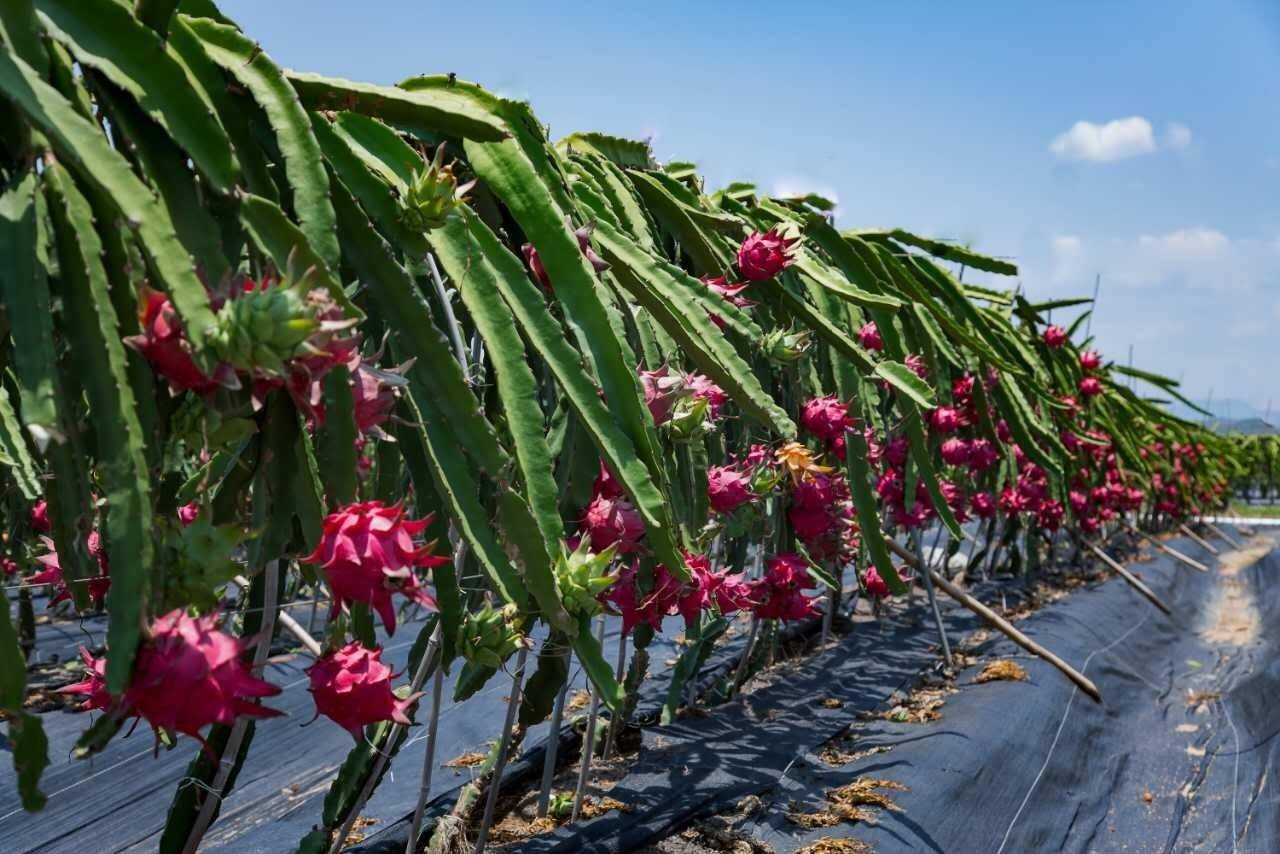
[501,524,1280,854]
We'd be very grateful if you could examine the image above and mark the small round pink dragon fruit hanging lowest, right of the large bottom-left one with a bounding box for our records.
[306,640,421,741]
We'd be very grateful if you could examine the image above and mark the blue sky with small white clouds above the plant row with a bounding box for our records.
[220,0,1280,415]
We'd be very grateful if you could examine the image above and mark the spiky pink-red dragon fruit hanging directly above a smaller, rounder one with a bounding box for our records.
[302,501,449,635]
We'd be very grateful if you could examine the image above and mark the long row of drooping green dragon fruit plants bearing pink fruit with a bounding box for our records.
[0,0,1231,851]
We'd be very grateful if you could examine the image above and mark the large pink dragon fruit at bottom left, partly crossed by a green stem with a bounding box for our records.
[64,609,283,743]
